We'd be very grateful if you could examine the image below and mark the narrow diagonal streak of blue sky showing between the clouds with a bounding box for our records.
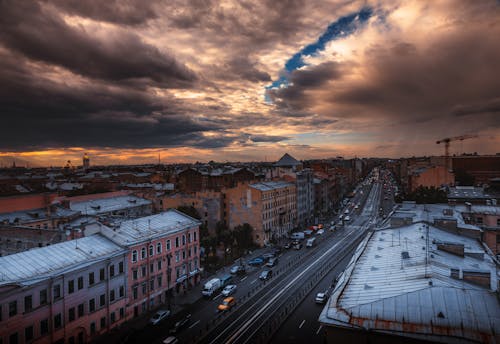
[266,7,373,101]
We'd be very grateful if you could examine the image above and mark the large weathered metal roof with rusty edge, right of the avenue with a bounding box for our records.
[319,223,500,342]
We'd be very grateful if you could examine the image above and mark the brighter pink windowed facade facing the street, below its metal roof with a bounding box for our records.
[127,227,200,318]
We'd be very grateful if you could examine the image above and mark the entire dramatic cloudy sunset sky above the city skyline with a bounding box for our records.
[0,0,500,165]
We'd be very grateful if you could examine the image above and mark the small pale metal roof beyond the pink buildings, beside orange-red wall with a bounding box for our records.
[70,195,151,215]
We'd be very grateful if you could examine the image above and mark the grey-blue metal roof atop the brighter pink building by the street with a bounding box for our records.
[101,209,201,246]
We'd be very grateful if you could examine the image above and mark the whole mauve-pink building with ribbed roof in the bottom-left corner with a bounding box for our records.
[0,234,127,344]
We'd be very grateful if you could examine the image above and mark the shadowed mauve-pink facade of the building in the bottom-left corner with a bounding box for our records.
[0,254,126,343]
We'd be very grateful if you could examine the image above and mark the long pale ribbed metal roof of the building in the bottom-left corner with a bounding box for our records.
[0,234,125,285]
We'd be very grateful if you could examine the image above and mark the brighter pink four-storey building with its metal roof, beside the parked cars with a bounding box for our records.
[101,209,200,318]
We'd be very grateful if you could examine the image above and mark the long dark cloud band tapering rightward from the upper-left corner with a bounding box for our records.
[0,1,196,87]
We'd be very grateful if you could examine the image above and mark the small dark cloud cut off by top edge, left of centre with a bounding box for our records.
[48,0,158,25]
